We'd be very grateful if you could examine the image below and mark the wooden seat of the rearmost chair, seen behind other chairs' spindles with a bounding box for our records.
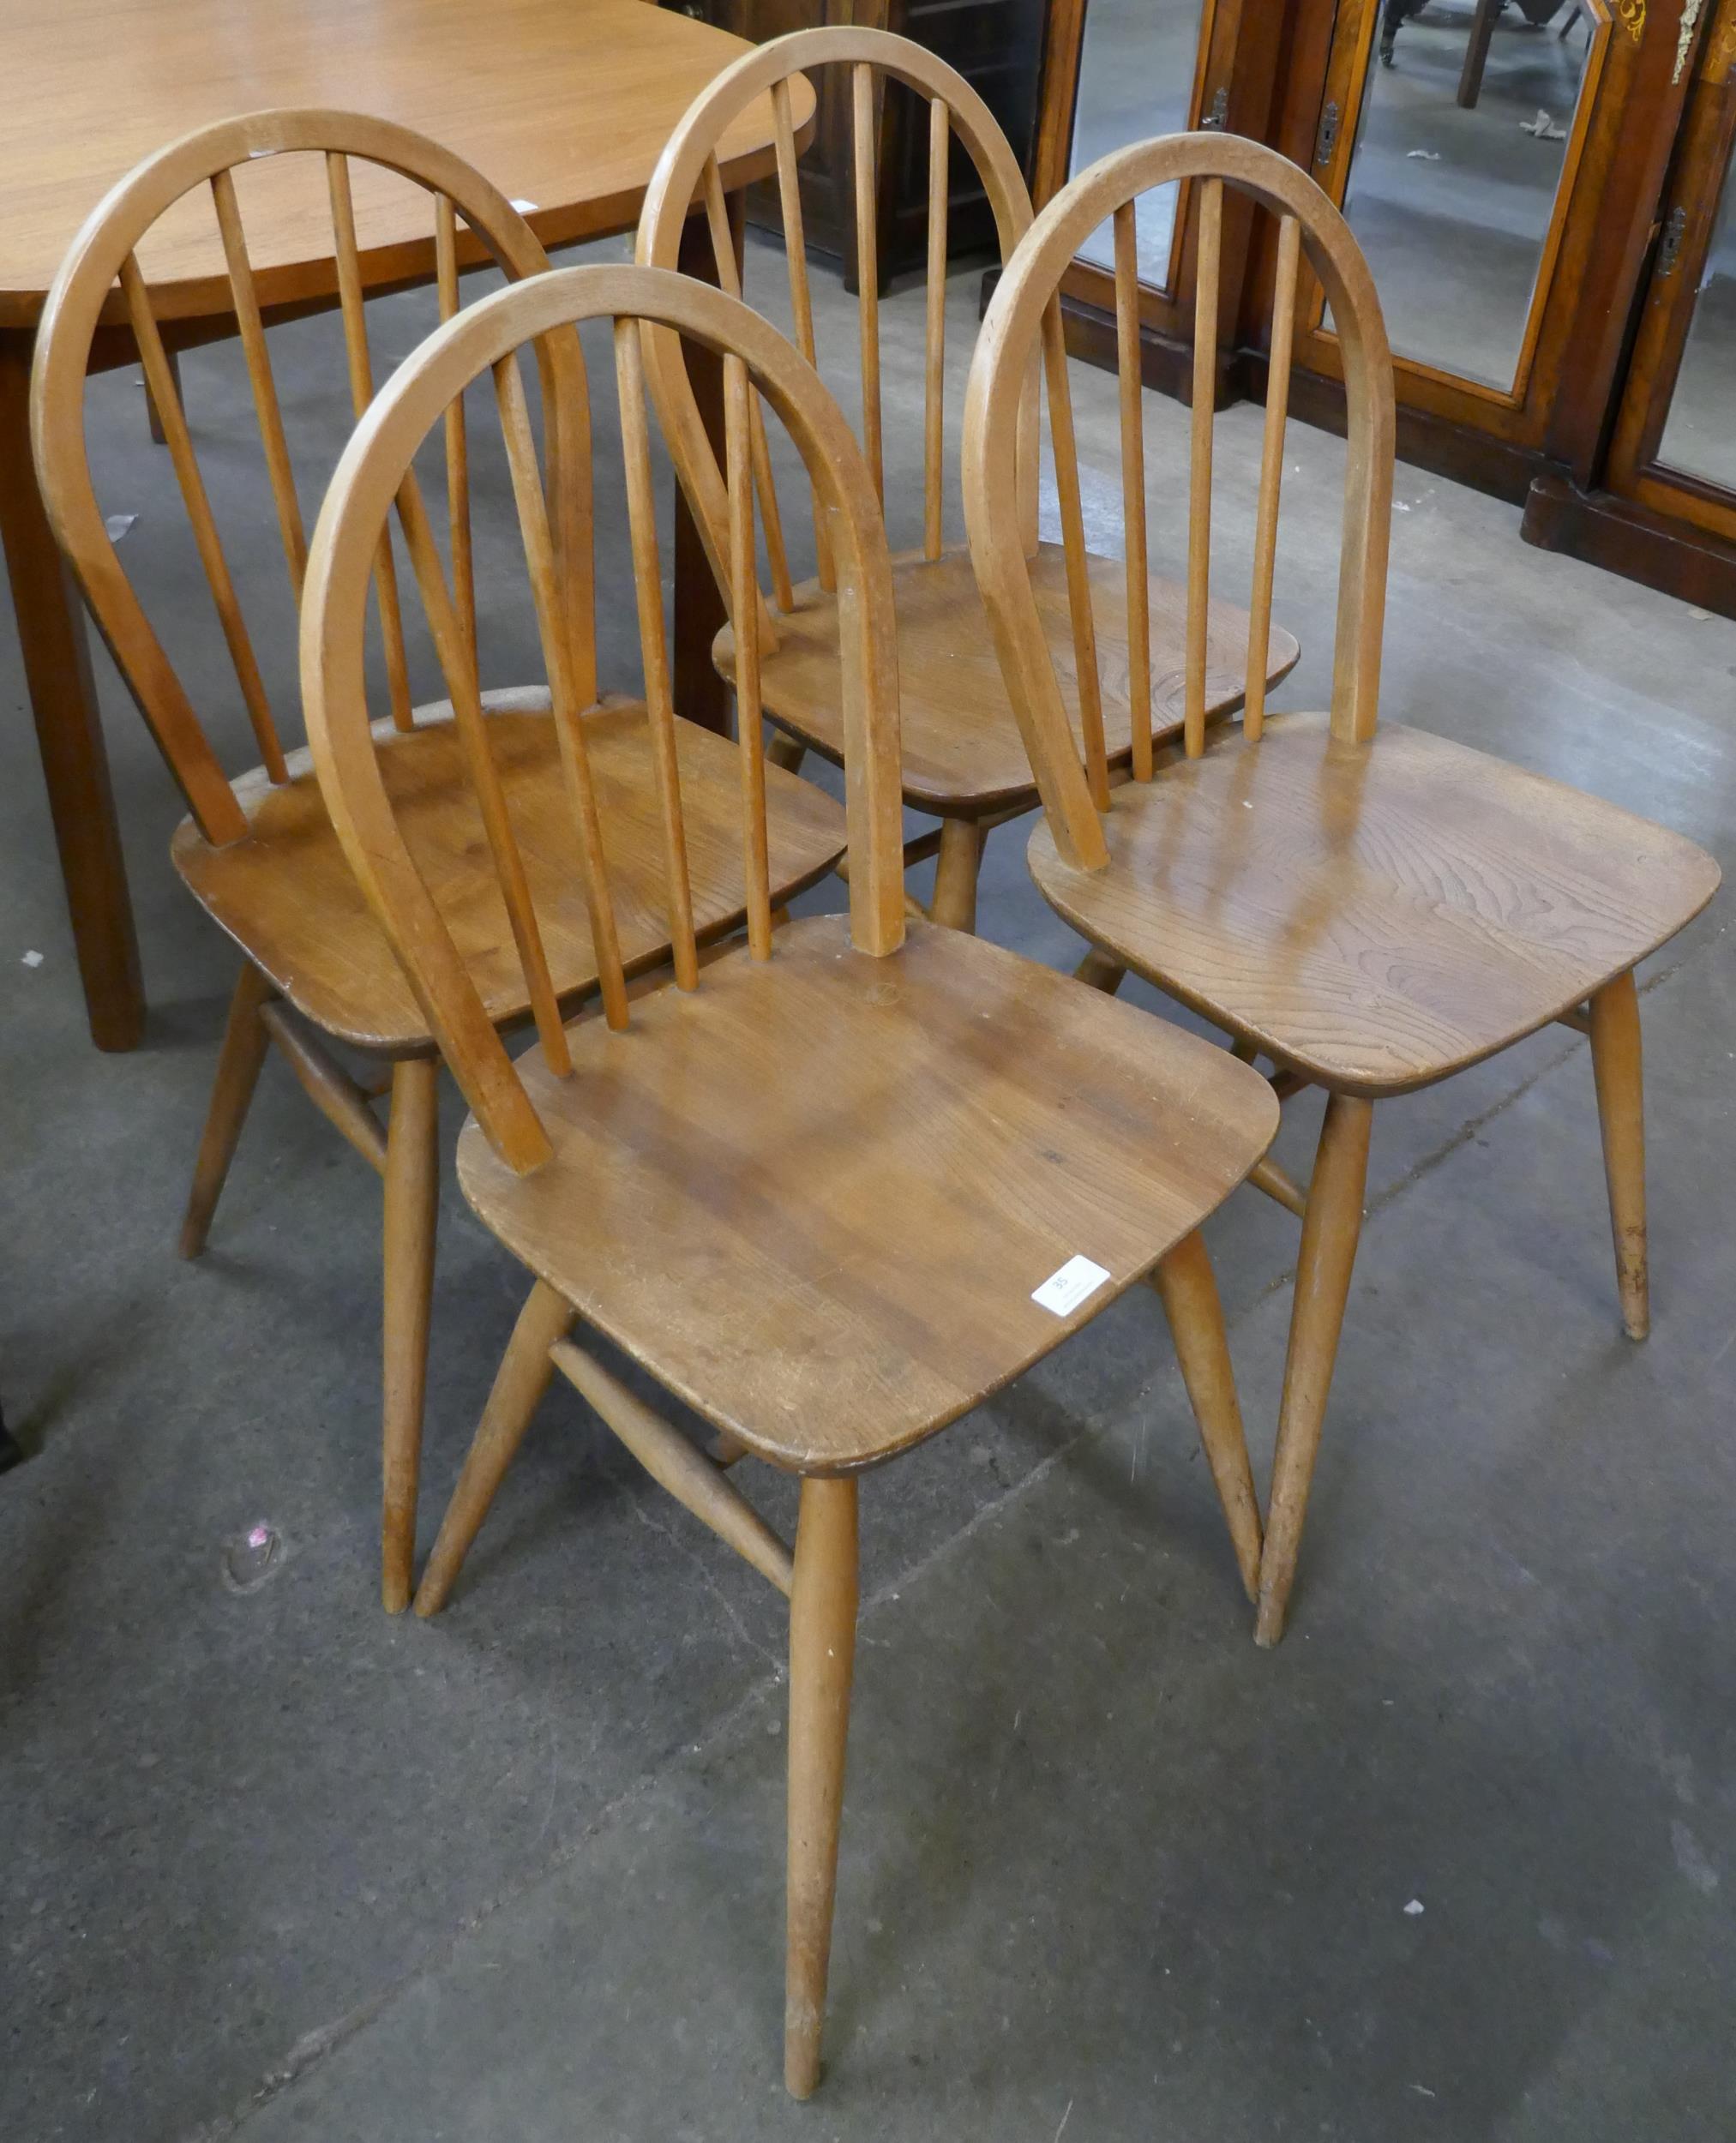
[714,543,1301,819]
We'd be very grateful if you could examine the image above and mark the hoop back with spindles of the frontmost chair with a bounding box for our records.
[300,266,904,1173]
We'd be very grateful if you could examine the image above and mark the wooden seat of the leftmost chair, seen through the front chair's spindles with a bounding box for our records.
[174,688,844,1054]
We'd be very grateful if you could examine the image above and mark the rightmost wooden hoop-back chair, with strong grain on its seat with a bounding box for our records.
[964,133,1719,1644]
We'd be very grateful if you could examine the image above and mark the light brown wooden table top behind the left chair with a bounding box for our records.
[0,0,813,328]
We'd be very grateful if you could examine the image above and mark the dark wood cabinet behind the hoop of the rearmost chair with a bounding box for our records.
[686,0,1048,291]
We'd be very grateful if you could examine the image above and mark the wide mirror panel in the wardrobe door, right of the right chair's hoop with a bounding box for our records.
[1344,0,1610,393]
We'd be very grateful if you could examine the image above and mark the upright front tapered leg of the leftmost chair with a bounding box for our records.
[380,1057,440,1614]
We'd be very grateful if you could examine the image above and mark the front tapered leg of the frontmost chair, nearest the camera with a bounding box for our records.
[784,1477,857,2098]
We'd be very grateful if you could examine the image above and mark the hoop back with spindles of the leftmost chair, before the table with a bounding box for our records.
[30,110,562,844]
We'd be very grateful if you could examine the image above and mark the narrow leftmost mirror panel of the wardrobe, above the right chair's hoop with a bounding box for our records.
[1067,0,1207,290]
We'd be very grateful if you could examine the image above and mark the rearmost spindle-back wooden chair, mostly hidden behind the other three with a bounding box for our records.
[637,28,1297,930]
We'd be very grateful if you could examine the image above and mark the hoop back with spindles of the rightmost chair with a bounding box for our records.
[964,133,1393,868]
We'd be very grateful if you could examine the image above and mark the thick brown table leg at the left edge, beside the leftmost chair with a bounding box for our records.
[0,333,146,1050]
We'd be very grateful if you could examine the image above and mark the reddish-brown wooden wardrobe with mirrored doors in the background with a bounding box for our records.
[1033,0,1736,615]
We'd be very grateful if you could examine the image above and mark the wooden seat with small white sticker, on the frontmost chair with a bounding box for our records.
[459,915,1277,1473]
